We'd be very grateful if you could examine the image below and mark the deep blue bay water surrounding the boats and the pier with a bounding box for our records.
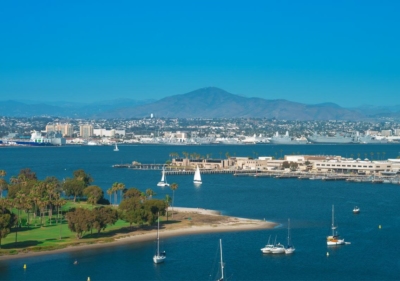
[0,145,400,281]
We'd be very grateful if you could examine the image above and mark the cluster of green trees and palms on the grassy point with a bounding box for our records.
[0,168,178,247]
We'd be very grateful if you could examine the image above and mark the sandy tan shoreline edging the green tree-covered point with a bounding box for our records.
[0,207,278,261]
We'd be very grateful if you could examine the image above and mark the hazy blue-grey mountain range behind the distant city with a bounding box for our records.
[0,87,400,121]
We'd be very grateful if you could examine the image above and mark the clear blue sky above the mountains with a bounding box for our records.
[0,0,400,107]
